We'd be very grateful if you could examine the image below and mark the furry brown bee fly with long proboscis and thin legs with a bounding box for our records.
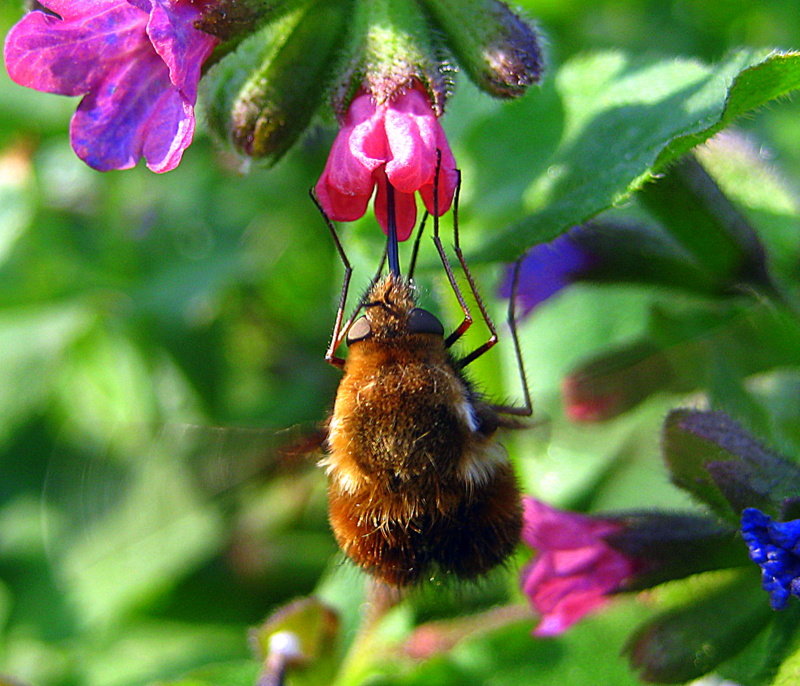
[310,171,531,587]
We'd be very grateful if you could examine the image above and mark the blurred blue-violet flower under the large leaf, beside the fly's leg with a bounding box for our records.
[500,227,594,317]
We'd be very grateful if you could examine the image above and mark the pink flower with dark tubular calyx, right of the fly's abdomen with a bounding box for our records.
[522,498,749,636]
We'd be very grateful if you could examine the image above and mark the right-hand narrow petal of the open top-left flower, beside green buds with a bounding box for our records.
[147,0,218,104]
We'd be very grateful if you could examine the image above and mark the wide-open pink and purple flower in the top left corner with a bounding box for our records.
[4,0,217,172]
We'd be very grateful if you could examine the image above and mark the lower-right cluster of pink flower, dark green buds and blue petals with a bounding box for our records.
[522,410,800,683]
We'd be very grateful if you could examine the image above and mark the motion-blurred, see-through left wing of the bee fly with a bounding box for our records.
[42,425,321,625]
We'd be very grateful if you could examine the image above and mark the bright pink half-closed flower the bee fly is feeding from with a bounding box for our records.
[315,83,458,241]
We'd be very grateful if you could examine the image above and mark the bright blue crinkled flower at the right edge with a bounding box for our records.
[742,507,800,610]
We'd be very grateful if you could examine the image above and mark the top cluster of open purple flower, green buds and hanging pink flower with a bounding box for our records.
[5,0,542,240]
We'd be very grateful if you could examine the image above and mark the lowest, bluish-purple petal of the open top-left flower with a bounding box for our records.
[70,53,194,172]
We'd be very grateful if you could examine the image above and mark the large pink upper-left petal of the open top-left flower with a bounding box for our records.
[4,0,147,95]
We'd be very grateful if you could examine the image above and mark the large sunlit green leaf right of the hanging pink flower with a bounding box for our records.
[469,50,800,262]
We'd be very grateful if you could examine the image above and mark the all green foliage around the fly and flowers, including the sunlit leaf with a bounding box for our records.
[0,0,800,686]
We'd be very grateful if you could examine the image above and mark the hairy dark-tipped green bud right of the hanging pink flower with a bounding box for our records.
[423,0,544,98]
